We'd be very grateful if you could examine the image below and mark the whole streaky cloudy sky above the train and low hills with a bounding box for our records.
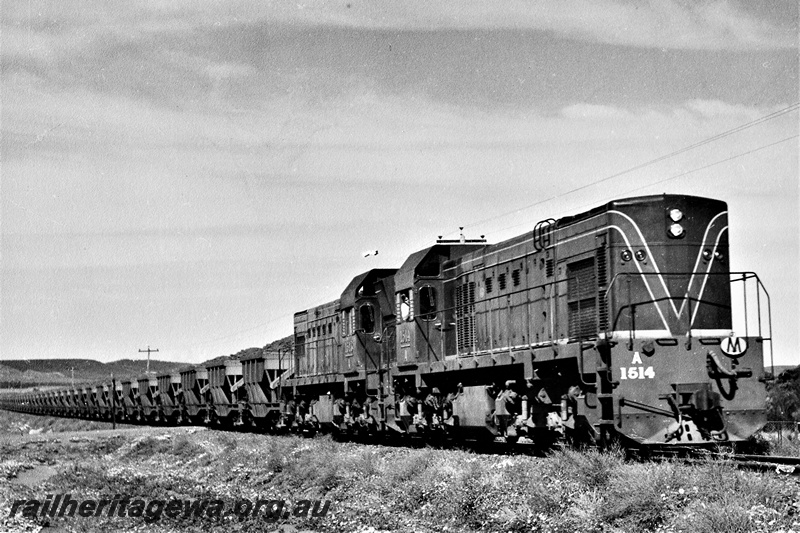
[0,0,800,364]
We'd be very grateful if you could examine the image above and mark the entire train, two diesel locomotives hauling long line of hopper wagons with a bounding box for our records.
[3,194,771,447]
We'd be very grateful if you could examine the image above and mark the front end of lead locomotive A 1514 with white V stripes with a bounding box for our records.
[598,195,771,444]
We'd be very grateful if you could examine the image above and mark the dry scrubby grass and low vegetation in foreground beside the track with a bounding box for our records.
[0,414,800,533]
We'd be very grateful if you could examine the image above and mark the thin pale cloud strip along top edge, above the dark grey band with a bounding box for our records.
[3,0,798,67]
